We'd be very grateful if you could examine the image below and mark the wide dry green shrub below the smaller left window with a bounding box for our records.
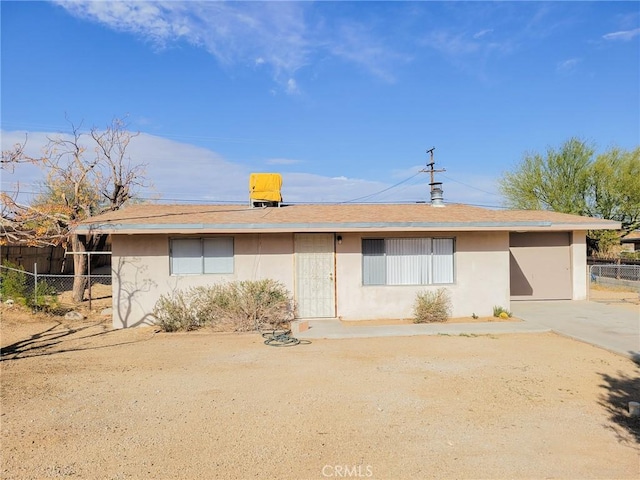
[154,279,293,332]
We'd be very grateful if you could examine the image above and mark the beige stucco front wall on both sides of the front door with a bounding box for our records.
[112,232,510,328]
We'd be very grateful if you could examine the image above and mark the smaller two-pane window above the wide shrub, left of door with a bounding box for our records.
[169,237,233,275]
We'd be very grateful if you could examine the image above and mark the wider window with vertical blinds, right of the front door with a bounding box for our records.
[362,238,453,285]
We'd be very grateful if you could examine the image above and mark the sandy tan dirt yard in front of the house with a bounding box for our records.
[0,286,640,479]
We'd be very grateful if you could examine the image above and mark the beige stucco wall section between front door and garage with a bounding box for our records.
[336,232,509,320]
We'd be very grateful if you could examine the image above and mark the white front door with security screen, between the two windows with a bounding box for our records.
[295,233,336,318]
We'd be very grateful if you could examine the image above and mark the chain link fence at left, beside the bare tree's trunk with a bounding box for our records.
[0,265,111,309]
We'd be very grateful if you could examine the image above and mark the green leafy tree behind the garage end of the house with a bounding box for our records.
[499,138,640,252]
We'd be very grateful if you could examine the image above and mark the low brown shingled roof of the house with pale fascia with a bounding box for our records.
[76,203,620,234]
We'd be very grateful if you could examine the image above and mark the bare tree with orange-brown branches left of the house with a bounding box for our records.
[0,118,146,302]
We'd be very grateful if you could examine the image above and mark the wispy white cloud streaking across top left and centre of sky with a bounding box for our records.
[56,0,401,94]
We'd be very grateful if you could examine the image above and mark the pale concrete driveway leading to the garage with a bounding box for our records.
[511,300,640,362]
